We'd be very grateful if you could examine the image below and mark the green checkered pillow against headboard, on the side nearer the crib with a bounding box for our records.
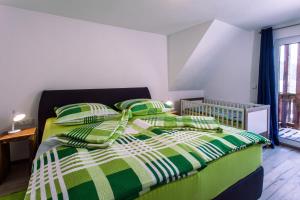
[115,99,173,115]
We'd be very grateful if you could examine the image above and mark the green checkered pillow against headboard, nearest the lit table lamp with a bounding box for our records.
[55,103,121,125]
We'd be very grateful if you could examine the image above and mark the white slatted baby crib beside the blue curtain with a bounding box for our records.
[181,98,270,137]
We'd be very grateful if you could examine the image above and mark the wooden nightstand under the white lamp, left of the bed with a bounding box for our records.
[0,128,36,184]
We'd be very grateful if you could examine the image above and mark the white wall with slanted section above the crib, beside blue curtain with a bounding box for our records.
[168,20,259,102]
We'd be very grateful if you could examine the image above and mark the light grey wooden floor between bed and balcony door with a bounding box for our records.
[260,146,300,200]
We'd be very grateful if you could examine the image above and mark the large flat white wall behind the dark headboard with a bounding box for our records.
[0,6,168,158]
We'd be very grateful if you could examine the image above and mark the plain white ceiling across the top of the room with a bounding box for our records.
[0,0,300,35]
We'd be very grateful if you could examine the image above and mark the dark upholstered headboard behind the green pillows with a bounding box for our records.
[37,87,151,145]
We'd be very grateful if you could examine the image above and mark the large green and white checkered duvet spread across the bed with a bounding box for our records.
[25,114,269,199]
